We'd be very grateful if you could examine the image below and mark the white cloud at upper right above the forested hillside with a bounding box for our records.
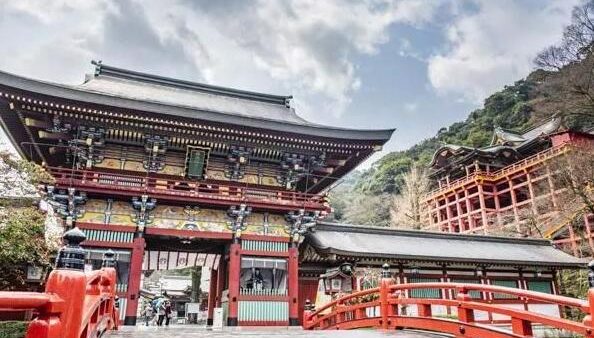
[428,0,578,103]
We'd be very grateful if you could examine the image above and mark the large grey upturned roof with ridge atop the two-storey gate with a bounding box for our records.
[0,64,394,141]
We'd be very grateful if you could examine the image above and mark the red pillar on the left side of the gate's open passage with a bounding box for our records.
[124,237,144,325]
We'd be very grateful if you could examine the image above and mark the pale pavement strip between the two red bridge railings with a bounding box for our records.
[105,325,444,338]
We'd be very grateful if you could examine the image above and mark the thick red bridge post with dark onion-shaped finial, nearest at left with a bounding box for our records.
[45,228,87,338]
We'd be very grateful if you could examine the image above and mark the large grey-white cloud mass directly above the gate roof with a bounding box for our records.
[0,0,445,119]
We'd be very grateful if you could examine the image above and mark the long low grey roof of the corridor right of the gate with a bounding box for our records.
[307,222,585,268]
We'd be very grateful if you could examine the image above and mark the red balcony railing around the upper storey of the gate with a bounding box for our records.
[47,167,329,211]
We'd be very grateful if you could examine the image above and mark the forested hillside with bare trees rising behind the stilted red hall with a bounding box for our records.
[330,1,594,226]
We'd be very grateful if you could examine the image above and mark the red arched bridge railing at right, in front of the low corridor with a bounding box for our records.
[303,266,594,338]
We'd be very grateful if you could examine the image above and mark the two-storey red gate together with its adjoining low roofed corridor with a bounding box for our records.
[0,62,583,326]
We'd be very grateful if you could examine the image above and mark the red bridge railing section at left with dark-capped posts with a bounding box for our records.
[0,228,118,338]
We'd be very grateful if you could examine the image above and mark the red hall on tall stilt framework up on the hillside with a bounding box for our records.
[424,118,594,257]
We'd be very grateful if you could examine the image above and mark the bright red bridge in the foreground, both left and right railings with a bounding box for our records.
[0,228,594,338]
